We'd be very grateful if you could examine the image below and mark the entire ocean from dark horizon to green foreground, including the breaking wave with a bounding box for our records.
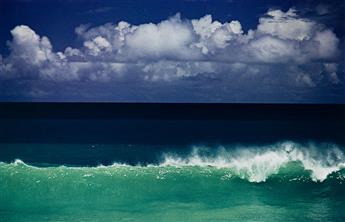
[0,103,345,221]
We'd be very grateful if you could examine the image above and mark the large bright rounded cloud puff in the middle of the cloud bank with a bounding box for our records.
[122,15,199,60]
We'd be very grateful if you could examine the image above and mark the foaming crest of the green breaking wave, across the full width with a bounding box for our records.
[0,142,345,182]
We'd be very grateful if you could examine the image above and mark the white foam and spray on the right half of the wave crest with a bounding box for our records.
[160,142,345,182]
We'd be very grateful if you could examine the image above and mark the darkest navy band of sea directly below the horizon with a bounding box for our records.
[0,103,345,145]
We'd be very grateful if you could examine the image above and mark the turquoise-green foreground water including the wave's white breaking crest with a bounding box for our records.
[0,143,345,221]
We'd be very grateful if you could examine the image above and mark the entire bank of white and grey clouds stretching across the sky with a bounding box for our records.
[0,9,341,87]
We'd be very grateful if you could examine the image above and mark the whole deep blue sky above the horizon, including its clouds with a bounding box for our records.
[0,0,345,103]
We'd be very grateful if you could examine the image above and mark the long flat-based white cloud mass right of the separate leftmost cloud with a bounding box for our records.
[69,9,339,63]
